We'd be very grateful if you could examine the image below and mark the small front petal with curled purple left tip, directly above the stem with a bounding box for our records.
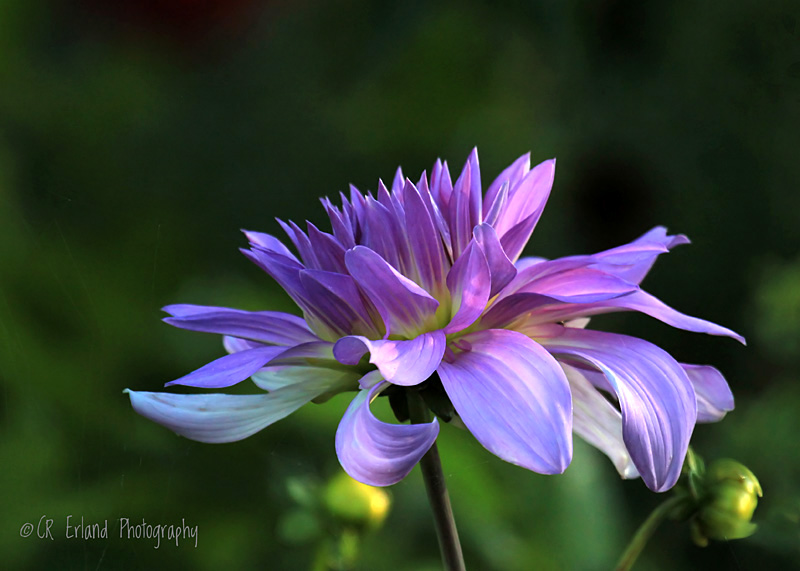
[333,331,447,386]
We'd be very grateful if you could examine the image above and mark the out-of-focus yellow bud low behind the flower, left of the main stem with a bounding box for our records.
[322,472,391,528]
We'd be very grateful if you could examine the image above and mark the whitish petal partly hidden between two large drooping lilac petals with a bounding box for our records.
[561,363,639,479]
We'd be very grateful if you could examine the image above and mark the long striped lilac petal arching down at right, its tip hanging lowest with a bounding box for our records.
[540,327,697,492]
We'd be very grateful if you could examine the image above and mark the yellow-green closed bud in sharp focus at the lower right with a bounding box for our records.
[692,459,762,546]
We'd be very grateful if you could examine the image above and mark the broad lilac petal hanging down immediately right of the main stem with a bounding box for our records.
[438,329,572,474]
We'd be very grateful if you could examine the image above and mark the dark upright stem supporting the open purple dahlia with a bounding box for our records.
[406,389,466,571]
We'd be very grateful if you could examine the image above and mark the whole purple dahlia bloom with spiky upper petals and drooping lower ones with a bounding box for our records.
[129,151,744,491]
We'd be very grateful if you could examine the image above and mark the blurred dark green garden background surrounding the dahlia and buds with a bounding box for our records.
[0,0,800,571]
